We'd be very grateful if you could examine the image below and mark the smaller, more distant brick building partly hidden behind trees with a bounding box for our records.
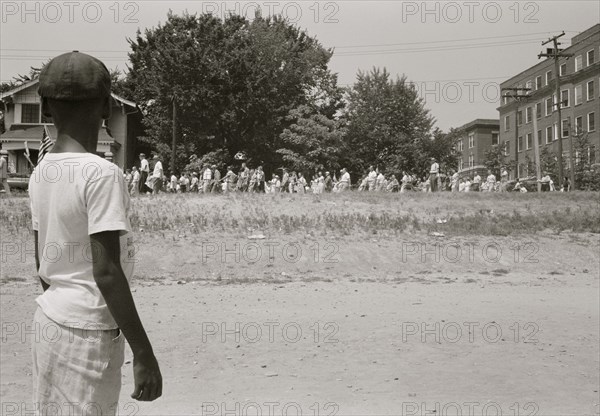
[456,118,500,176]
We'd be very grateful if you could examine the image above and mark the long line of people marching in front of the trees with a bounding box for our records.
[124,153,555,195]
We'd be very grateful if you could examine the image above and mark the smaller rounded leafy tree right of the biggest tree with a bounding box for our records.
[346,68,434,173]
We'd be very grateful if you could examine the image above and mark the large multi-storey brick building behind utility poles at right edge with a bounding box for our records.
[498,24,600,178]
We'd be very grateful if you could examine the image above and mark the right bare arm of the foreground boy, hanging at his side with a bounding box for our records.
[90,231,162,401]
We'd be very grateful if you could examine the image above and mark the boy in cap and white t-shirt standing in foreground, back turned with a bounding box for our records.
[29,52,162,415]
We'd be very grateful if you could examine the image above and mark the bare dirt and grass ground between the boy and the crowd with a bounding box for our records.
[0,193,600,415]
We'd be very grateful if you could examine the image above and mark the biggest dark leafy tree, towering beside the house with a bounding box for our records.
[129,13,331,170]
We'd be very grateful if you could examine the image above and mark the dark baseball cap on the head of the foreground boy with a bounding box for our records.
[38,51,110,101]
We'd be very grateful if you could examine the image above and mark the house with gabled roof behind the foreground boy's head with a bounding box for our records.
[0,78,143,174]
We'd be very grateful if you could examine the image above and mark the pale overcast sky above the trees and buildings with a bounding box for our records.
[0,0,600,130]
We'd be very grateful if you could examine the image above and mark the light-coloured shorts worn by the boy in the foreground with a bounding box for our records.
[32,307,125,416]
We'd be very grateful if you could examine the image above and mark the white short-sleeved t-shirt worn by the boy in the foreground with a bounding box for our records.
[29,153,135,330]
